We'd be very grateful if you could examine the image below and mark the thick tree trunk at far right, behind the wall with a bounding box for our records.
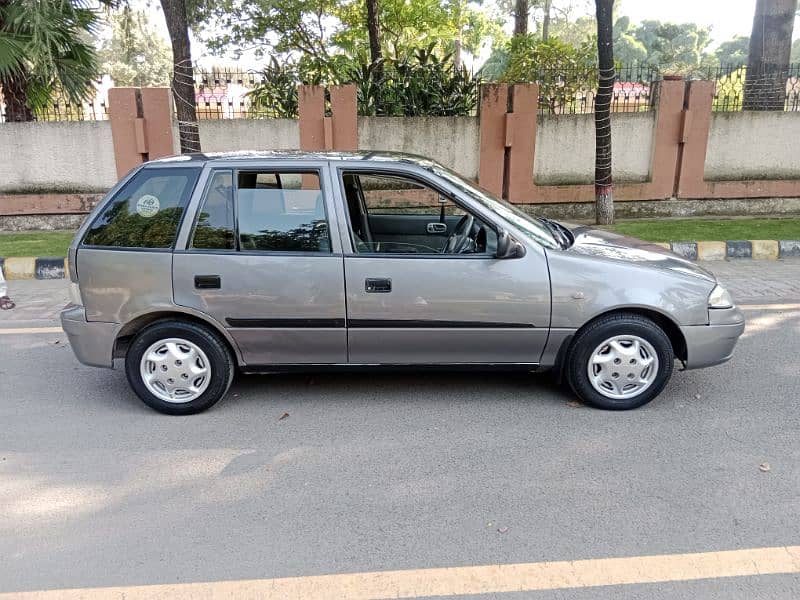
[742,0,797,110]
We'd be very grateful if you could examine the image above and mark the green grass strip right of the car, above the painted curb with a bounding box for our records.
[613,219,800,242]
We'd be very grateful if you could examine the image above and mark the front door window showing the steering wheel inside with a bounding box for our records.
[341,171,497,255]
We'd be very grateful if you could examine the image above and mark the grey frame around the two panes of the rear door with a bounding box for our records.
[175,159,342,257]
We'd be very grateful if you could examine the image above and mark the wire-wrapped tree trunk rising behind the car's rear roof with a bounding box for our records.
[161,0,201,154]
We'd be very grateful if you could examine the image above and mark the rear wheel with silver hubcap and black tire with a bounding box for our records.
[125,320,235,415]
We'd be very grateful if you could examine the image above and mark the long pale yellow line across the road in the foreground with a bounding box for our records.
[0,546,800,600]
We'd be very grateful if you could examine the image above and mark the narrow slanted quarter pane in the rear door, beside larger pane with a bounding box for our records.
[191,171,236,250]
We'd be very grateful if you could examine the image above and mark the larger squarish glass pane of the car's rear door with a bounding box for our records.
[236,170,331,252]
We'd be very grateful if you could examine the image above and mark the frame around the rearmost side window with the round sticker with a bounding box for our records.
[75,162,205,253]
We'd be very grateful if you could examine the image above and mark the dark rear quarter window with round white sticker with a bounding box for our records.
[83,167,200,248]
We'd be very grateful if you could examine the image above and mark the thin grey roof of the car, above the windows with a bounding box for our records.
[149,150,437,169]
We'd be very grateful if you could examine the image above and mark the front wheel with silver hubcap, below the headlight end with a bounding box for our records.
[565,313,675,410]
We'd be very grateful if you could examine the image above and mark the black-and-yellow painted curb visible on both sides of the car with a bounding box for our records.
[0,240,800,280]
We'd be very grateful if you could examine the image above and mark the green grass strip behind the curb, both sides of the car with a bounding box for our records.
[0,218,800,257]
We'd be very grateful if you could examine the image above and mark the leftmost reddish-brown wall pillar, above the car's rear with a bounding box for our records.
[108,88,174,177]
